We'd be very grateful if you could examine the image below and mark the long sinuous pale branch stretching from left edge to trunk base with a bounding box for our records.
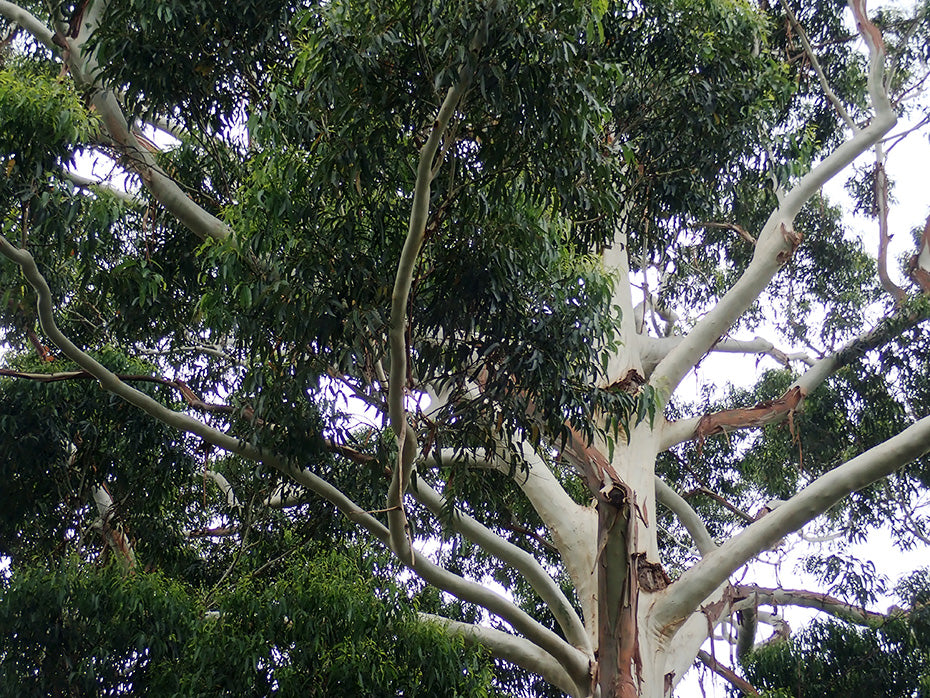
[0,230,588,683]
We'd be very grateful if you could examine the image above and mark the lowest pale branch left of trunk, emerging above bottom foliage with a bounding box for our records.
[417,612,586,698]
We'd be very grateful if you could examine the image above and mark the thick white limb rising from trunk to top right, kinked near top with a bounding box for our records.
[652,0,897,395]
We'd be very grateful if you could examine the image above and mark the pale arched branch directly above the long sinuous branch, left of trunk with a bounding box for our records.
[411,478,594,657]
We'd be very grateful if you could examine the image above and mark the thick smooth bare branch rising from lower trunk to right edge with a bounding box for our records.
[654,408,930,636]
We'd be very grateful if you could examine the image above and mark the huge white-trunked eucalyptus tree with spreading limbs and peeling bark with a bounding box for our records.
[0,0,930,698]
